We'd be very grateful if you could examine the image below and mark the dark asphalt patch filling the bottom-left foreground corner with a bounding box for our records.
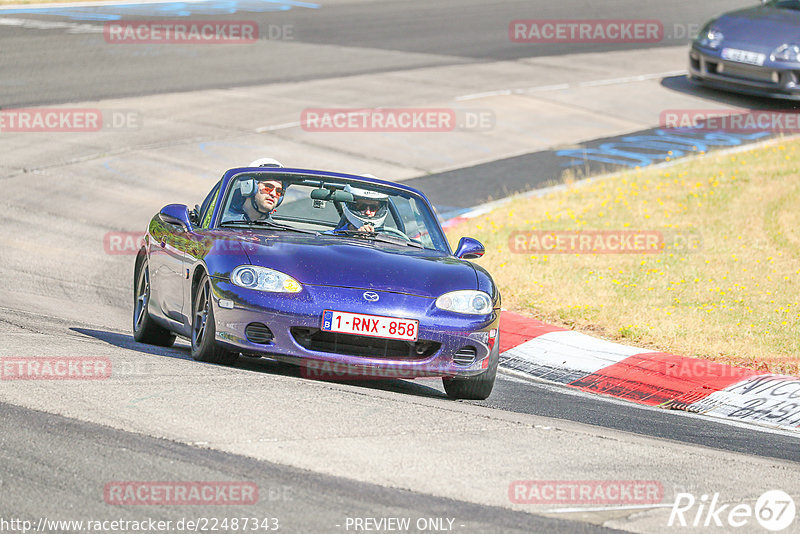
[0,405,613,533]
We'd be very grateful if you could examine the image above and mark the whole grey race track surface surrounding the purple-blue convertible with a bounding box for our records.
[0,0,800,533]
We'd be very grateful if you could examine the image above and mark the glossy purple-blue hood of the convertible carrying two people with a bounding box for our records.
[234,234,478,298]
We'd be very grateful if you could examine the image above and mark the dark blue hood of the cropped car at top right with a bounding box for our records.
[712,6,800,50]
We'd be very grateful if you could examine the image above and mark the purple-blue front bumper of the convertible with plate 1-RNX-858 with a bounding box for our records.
[206,278,500,378]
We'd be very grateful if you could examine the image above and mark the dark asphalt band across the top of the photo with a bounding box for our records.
[0,0,748,107]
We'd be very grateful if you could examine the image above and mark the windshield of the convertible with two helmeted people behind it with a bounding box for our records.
[219,172,449,252]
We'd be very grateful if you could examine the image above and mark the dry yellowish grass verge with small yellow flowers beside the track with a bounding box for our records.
[448,136,800,374]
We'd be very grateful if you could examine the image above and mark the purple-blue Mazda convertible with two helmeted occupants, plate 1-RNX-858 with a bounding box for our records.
[133,167,500,399]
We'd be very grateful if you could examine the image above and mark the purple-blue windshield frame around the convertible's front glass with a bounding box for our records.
[209,167,453,256]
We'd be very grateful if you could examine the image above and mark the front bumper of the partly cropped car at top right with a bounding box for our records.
[689,44,800,100]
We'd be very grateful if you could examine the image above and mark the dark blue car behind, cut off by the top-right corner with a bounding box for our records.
[689,0,800,99]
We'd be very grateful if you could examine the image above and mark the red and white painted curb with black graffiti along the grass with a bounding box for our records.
[500,312,800,431]
